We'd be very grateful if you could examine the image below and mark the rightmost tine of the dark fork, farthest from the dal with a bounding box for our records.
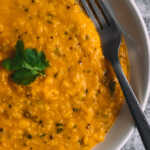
[96,0,115,25]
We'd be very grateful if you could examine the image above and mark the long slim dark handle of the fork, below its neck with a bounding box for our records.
[112,61,150,150]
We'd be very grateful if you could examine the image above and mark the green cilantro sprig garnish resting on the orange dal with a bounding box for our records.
[2,40,49,85]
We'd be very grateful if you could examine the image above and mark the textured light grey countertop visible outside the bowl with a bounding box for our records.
[121,0,150,150]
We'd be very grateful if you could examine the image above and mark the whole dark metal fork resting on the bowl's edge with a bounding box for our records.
[80,0,150,150]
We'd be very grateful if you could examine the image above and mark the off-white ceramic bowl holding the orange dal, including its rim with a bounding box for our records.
[93,0,150,150]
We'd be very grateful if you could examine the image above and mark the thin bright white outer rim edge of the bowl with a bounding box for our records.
[116,0,150,150]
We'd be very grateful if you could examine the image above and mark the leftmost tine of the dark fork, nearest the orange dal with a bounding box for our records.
[80,0,100,28]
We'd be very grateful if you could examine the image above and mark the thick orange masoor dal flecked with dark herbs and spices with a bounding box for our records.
[0,0,128,150]
